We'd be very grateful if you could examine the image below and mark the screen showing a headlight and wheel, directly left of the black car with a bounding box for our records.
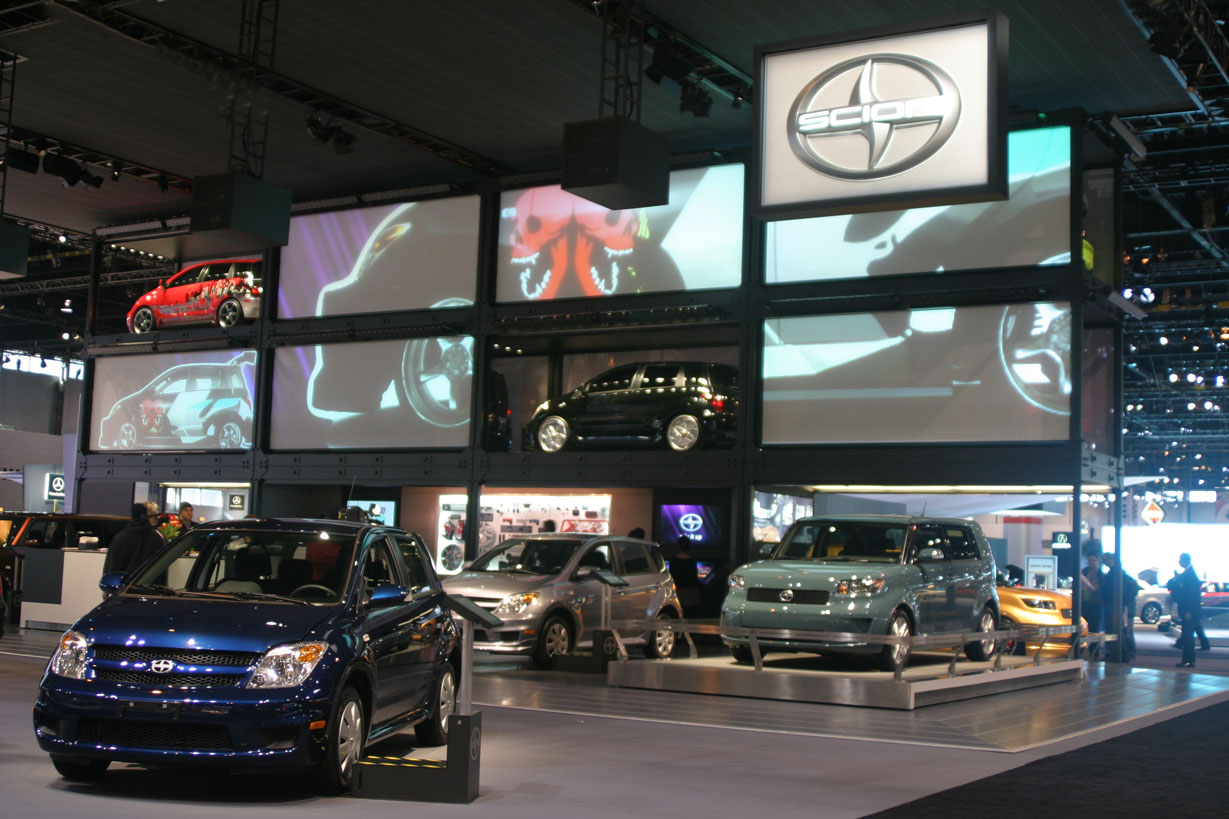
[269,336,473,450]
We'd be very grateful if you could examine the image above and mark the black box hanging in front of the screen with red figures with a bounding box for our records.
[563,117,670,210]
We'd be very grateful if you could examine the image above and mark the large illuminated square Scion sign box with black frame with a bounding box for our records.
[755,12,1008,219]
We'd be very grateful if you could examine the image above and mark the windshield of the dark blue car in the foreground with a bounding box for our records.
[124,529,355,604]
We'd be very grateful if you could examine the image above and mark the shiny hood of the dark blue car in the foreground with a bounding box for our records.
[74,595,337,653]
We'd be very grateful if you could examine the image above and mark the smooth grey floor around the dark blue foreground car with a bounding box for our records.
[0,630,1229,819]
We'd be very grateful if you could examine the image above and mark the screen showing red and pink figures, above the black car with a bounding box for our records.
[495,165,744,301]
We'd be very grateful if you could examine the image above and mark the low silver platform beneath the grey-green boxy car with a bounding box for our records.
[606,653,1084,711]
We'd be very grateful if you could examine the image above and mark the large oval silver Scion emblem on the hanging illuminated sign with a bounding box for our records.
[787,54,960,180]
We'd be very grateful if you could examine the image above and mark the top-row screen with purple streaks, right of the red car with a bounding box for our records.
[278,196,481,319]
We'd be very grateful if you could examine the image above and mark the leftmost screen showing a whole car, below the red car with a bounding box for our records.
[90,350,256,451]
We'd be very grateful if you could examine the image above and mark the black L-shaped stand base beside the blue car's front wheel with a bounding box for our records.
[350,711,482,803]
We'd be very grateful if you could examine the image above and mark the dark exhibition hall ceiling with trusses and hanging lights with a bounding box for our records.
[0,0,1229,482]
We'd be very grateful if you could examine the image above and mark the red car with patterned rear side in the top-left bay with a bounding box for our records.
[128,258,263,333]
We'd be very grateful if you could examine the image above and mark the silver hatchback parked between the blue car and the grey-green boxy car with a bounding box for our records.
[444,532,682,668]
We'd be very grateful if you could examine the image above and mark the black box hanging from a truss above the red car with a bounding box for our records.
[188,173,290,252]
